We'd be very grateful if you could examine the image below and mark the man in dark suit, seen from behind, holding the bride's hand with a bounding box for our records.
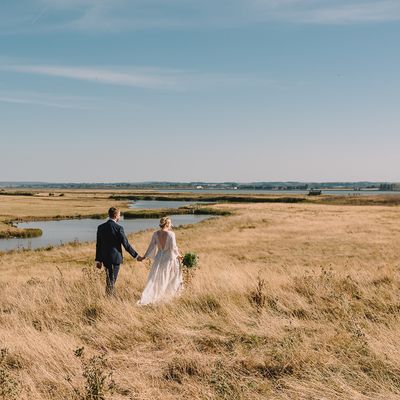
[96,207,143,295]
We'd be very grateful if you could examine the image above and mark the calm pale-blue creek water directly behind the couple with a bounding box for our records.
[0,214,210,251]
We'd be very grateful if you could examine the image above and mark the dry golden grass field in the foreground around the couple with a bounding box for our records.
[0,204,400,400]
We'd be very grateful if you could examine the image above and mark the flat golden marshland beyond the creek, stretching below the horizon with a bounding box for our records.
[0,189,400,221]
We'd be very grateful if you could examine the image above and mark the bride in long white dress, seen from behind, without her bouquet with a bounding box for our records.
[138,217,183,305]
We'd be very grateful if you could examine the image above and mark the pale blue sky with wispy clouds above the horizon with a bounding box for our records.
[0,0,400,182]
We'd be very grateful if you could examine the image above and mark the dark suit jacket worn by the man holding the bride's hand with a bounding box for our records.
[96,219,138,266]
